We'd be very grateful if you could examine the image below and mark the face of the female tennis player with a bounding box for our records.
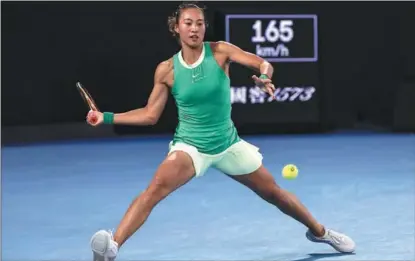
[176,8,206,48]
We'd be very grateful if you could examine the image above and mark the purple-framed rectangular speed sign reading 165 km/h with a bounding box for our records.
[225,14,318,62]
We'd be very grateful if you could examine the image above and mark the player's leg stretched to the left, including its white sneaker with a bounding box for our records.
[91,151,195,261]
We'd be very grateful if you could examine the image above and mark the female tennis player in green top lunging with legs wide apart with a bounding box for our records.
[87,4,355,261]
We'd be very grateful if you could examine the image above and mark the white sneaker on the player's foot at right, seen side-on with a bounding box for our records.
[306,229,356,253]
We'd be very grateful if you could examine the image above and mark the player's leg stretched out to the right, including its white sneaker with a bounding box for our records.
[229,166,355,252]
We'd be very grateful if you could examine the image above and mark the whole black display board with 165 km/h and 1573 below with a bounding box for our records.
[225,14,319,124]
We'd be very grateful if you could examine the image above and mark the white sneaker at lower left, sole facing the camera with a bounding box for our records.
[90,230,118,261]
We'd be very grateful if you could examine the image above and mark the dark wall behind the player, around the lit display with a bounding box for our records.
[1,1,415,144]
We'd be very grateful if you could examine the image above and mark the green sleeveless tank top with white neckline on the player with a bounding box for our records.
[171,42,239,155]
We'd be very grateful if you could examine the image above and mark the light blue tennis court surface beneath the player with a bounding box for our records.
[2,134,415,261]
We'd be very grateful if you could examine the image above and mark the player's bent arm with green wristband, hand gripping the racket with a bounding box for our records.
[87,62,171,126]
